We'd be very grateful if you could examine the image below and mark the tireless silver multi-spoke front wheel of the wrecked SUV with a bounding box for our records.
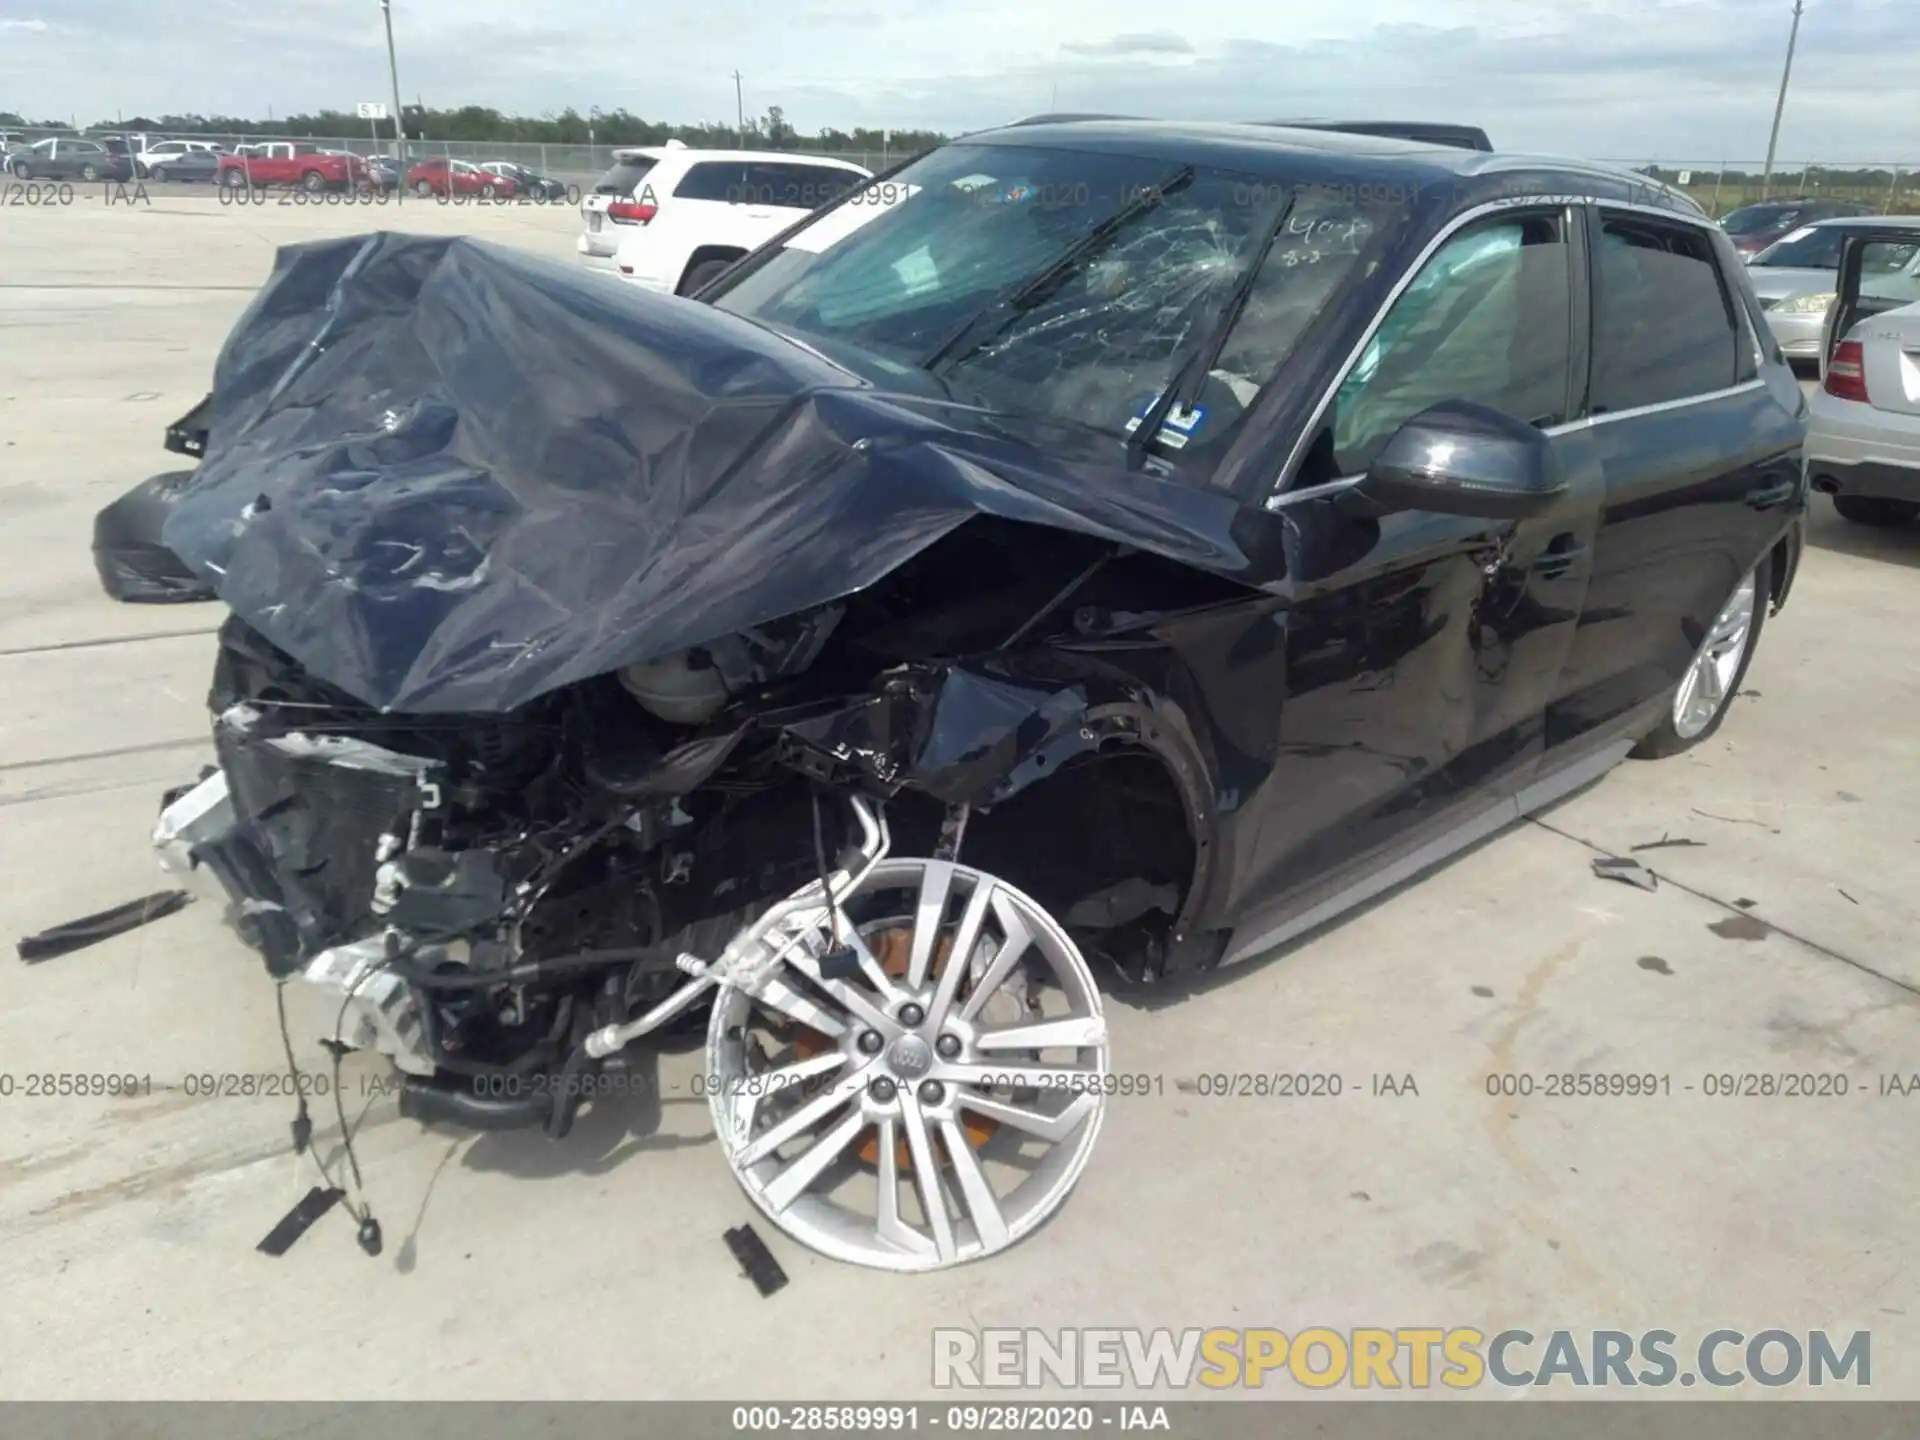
[703,858,1108,1271]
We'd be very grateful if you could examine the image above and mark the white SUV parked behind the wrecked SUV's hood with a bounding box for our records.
[578,144,872,294]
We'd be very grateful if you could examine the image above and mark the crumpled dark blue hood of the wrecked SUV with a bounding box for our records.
[165,232,1250,712]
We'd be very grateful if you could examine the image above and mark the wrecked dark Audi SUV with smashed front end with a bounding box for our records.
[145,119,1807,1269]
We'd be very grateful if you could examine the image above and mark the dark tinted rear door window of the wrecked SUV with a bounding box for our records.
[1592,215,1741,415]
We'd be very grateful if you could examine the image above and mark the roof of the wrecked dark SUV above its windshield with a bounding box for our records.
[962,115,1703,215]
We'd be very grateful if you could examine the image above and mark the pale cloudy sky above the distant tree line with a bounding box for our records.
[0,0,1920,165]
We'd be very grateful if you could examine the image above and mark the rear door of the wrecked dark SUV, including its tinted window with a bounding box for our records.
[1548,202,1805,747]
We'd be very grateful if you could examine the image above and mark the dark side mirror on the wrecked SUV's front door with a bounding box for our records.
[1354,399,1567,520]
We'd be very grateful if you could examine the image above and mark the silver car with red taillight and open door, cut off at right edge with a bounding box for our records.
[1807,231,1920,526]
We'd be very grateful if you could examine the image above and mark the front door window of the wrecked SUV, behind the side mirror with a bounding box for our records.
[1332,211,1572,474]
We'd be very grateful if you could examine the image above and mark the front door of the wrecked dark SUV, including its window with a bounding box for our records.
[1229,204,1599,947]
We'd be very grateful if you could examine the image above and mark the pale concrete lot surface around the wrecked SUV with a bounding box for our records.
[0,194,1920,1400]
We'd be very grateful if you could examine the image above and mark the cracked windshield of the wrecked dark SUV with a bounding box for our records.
[714,144,1404,445]
